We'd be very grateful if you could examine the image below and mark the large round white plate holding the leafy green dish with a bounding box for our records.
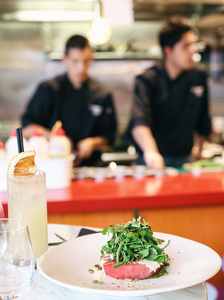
[38,232,222,297]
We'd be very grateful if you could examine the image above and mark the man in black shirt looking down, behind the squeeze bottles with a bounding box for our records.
[22,35,116,165]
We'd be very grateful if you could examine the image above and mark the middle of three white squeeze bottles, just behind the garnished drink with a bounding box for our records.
[28,126,49,159]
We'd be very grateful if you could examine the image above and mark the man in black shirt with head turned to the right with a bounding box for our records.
[129,17,211,169]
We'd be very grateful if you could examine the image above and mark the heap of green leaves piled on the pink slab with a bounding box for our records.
[101,217,169,268]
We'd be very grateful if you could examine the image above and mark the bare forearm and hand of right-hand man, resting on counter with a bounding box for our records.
[132,125,164,170]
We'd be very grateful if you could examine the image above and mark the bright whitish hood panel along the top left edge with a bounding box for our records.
[0,0,101,22]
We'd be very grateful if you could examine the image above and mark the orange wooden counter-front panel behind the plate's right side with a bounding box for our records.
[139,205,224,286]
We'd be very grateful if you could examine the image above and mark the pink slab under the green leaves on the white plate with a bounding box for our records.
[103,254,161,280]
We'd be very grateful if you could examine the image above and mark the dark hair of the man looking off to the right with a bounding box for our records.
[159,16,195,49]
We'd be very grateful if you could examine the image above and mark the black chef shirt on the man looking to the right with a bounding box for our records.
[129,64,211,157]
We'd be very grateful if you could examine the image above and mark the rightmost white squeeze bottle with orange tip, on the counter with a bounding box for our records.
[50,127,71,157]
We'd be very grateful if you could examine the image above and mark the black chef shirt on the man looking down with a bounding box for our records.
[22,74,116,164]
